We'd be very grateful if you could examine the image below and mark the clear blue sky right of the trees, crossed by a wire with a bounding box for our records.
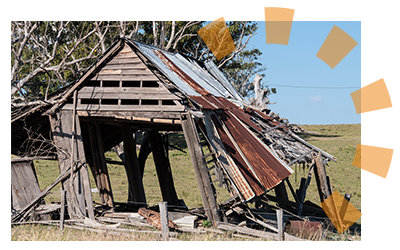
[245,21,361,124]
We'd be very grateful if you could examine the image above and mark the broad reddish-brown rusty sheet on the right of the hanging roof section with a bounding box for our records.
[217,110,292,190]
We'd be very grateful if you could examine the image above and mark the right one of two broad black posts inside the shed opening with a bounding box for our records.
[149,130,179,205]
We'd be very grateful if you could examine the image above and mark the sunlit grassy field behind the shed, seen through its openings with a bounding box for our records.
[11,124,361,240]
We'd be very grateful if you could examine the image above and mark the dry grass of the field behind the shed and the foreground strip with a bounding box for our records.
[11,124,361,241]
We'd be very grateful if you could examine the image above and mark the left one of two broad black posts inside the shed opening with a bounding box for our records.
[121,125,146,207]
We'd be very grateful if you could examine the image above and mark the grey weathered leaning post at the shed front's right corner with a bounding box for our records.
[181,112,221,228]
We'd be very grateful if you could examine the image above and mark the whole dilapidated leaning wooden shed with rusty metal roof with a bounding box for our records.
[11,39,336,226]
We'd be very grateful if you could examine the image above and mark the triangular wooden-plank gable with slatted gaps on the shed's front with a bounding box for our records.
[62,43,184,116]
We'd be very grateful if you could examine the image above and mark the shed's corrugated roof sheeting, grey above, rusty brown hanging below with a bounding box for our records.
[131,42,293,200]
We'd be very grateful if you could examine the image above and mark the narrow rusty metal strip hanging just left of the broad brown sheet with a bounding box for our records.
[211,114,265,196]
